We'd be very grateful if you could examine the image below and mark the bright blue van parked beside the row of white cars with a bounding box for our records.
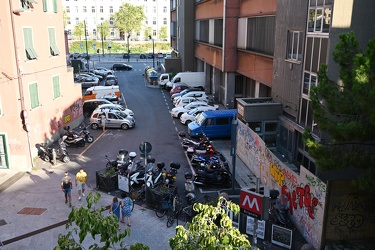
[188,109,237,138]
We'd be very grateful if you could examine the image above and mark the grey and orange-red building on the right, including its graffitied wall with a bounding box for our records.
[171,0,375,249]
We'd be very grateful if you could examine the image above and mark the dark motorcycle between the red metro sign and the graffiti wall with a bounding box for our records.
[269,189,289,227]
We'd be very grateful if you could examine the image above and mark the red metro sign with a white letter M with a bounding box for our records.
[240,189,268,220]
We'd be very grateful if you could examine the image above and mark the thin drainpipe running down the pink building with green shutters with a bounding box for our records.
[9,0,34,168]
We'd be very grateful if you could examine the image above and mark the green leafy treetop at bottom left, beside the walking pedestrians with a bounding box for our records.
[54,192,149,250]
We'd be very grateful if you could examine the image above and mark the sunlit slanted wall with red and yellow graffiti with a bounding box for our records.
[237,121,326,249]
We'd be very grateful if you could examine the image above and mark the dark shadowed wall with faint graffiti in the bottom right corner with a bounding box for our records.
[326,181,375,241]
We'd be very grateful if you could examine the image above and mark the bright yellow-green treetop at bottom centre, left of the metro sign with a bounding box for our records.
[169,197,251,250]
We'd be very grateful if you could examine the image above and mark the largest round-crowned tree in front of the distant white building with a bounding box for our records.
[112,3,146,39]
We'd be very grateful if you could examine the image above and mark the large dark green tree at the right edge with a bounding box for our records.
[305,32,375,191]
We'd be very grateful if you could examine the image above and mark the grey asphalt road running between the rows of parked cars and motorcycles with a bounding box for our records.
[68,62,201,201]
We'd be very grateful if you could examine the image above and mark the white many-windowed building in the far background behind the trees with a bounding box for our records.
[61,0,170,41]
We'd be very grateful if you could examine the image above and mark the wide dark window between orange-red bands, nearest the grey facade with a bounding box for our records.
[246,16,275,56]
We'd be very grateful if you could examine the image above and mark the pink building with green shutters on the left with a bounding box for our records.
[0,0,83,171]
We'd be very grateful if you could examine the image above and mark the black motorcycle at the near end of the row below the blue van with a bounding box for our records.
[194,164,232,187]
